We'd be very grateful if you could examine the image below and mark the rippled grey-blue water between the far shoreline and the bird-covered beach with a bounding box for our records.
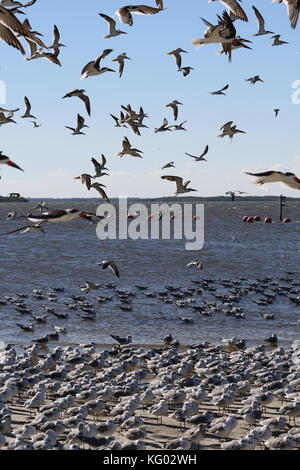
[0,196,300,344]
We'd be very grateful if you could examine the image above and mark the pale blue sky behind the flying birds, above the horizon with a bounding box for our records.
[0,0,300,199]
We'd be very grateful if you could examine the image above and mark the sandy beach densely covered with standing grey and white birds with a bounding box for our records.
[0,341,300,451]
